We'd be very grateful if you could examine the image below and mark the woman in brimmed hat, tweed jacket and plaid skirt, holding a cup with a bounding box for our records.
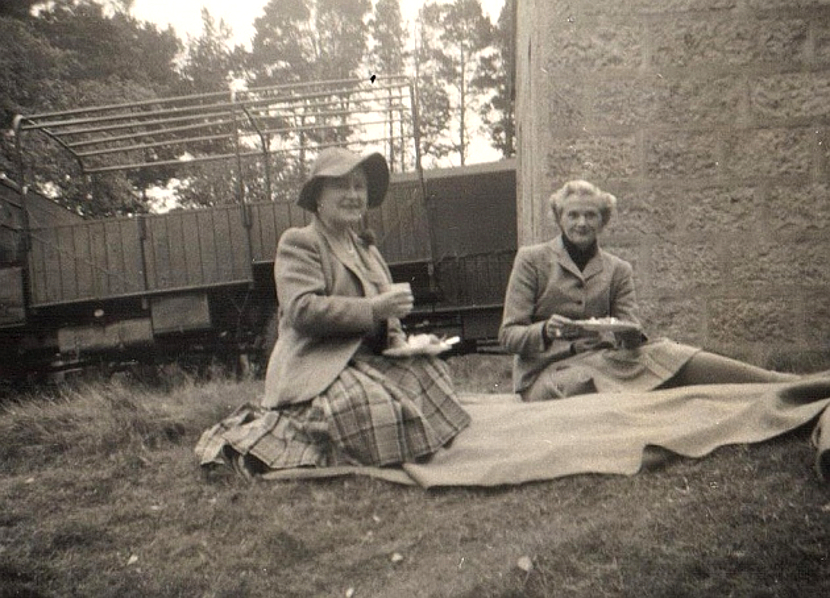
[262,148,470,468]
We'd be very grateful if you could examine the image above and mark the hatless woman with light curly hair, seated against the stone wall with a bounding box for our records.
[499,180,794,401]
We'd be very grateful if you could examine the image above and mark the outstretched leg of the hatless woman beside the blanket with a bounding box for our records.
[661,351,799,388]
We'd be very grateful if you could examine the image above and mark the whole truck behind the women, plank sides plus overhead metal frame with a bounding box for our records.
[0,76,516,376]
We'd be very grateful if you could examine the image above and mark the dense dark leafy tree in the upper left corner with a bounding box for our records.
[0,0,180,215]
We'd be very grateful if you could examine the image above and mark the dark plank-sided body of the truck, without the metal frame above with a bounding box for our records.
[0,160,516,377]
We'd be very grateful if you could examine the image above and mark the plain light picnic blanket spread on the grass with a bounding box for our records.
[198,372,830,488]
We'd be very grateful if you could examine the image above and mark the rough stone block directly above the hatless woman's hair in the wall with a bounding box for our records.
[545,135,638,181]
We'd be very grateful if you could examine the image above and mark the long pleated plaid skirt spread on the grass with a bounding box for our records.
[196,353,470,471]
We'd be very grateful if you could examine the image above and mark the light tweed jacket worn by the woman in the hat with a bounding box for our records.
[262,217,403,408]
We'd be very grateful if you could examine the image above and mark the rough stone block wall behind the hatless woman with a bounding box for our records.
[516,0,830,367]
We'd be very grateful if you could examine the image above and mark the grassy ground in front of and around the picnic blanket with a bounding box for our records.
[0,356,830,598]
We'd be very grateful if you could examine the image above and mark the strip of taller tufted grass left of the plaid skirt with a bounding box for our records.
[0,378,259,473]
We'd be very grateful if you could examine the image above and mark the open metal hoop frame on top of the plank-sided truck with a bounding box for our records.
[13,76,423,207]
